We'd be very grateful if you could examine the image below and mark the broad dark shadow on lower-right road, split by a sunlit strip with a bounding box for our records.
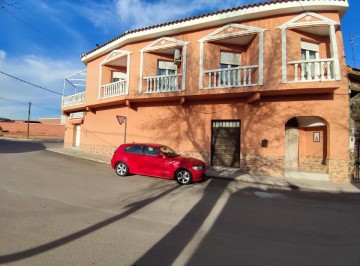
[133,179,360,266]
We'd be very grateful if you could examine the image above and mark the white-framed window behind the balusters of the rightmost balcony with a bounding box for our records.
[301,41,320,79]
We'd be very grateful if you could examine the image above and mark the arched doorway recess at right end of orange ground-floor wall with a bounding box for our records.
[285,116,329,180]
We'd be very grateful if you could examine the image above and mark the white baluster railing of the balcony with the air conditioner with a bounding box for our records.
[144,74,181,93]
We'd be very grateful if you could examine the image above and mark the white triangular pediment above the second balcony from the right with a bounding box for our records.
[199,24,266,42]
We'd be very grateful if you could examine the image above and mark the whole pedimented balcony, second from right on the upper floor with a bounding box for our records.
[199,23,266,89]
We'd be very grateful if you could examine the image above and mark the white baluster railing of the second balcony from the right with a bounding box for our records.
[204,65,258,89]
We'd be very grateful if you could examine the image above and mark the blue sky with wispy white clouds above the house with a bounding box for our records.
[0,0,360,119]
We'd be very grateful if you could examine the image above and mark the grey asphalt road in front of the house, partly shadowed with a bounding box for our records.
[0,139,360,266]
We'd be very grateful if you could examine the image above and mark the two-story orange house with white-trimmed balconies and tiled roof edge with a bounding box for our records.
[62,0,349,182]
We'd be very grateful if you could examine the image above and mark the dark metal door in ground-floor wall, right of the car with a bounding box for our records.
[211,120,240,167]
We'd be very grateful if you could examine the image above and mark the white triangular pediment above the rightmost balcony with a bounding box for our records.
[279,12,338,29]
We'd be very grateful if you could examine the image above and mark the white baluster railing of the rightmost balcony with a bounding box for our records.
[288,59,334,82]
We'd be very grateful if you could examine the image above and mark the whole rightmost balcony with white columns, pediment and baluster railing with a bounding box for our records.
[279,12,341,83]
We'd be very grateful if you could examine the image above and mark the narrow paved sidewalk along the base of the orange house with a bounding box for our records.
[47,147,360,193]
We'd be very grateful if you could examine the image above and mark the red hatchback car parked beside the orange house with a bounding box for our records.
[111,143,205,185]
